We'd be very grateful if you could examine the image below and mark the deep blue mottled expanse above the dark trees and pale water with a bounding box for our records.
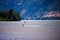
[0,0,60,20]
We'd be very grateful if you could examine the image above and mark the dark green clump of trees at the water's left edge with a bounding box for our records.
[0,8,21,21]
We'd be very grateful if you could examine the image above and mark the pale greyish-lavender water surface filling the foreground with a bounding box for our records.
[0,21,60,40]
